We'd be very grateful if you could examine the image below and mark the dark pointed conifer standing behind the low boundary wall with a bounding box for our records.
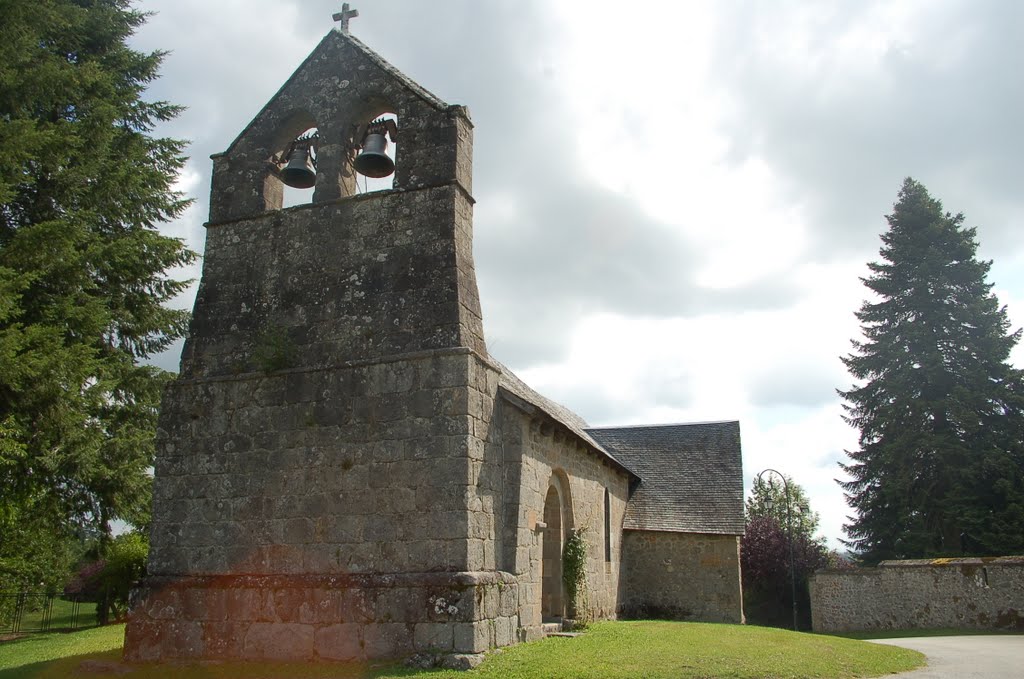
[840,178,1024,562]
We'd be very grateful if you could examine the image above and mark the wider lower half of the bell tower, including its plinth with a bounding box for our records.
[126,348,520,661]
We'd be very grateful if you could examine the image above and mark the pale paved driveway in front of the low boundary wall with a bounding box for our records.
[872,634,1024,679]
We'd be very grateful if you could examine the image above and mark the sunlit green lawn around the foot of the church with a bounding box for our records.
[0,622,924,679]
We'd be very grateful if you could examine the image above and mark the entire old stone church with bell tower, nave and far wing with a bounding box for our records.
[125,6,743,661]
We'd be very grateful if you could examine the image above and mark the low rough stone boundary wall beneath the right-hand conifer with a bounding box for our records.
[810,556,1024,632]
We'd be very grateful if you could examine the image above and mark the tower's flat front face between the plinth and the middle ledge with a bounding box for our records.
[150,350,491,576]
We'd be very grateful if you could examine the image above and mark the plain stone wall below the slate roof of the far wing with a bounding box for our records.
[618,531,743,624]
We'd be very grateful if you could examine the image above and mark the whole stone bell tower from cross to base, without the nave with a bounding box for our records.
[125,10,517,661]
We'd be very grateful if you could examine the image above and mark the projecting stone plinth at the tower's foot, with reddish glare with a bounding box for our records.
[125,572,519,662]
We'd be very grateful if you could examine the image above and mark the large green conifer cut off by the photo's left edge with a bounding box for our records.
[0,0,196,585]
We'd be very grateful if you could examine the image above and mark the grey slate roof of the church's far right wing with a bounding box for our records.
[587,422,743,536]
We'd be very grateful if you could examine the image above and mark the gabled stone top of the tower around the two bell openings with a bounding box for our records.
[210,31,473,223]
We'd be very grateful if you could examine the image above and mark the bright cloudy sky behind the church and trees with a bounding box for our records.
[134,0,1024,545]
